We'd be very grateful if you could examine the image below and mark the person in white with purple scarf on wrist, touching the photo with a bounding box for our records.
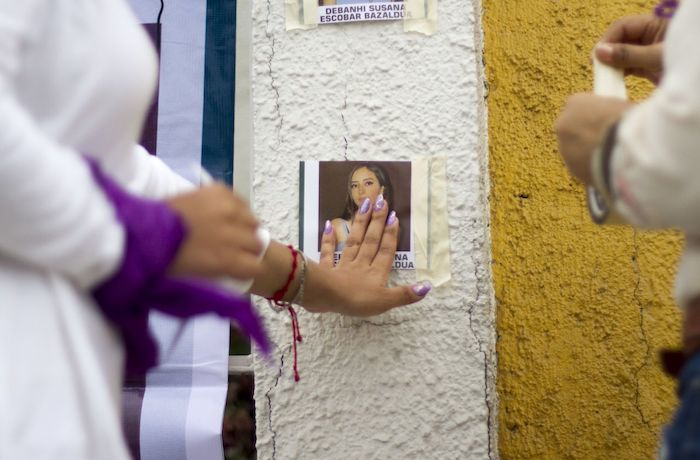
[0,0,429,460]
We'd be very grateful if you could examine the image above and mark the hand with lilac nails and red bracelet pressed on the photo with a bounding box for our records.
[251,196,430,316]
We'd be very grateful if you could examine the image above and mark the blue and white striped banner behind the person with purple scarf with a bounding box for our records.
[124,0,252,460]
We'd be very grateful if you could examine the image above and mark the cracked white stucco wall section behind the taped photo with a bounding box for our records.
[253,0,495,459]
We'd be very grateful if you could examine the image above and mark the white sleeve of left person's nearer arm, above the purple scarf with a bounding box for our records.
[0,4,124,288]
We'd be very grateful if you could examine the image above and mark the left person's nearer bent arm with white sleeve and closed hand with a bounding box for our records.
[0,0,260,289]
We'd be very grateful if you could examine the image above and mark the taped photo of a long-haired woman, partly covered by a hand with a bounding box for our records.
[299,161,415,270]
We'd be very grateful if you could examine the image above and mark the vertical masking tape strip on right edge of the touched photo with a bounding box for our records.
[411,156,452,286]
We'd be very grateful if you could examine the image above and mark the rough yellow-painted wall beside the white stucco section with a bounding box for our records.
[483,0,680,459]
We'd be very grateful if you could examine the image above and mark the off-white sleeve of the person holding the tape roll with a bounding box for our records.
[611,2,700,236]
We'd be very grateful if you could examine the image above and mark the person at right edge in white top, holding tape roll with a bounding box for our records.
[556,0,700,459]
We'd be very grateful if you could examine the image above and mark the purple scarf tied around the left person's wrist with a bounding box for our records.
[87,159,270,375]
